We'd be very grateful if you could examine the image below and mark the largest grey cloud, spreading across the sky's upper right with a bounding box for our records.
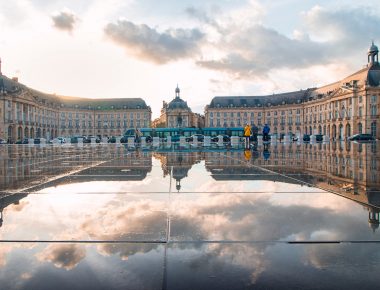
[191,6,380,79]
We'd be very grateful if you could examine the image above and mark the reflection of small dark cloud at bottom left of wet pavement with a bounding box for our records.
[37,244,86,270]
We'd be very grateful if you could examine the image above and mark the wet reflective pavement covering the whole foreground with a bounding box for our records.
[0,143,380,289]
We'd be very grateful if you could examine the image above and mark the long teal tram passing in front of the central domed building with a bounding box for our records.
[124,127,243,138]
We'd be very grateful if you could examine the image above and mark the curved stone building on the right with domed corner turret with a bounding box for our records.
[205,43,380,139]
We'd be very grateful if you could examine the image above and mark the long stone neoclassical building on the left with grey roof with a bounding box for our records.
[0,71,152,141]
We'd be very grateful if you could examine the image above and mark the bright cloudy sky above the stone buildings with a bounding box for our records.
[0,0,380,118]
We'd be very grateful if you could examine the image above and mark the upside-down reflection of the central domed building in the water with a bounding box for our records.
[154,152,201,192]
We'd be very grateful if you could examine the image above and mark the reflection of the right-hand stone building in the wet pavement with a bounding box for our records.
[205,142,380,228]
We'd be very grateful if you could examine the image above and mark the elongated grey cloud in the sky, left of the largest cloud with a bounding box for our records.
[104,20,204,64]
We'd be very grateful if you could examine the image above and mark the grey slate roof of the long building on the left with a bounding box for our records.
[0,75,149,110]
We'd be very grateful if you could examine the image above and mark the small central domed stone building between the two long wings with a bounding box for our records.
[153,86,204,128]
